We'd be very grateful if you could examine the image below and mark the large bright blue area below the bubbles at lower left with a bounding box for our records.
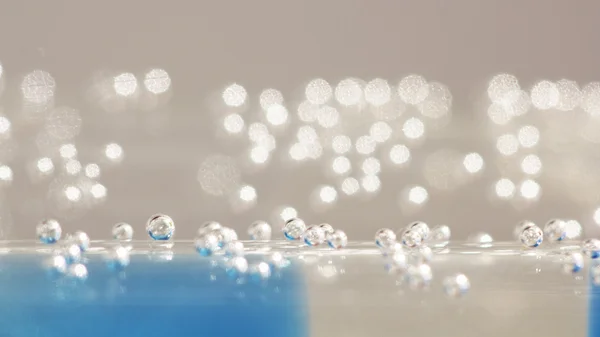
[0,254,309,337]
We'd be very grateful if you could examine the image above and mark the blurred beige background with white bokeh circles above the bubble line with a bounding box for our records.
[0,0,600,240]
